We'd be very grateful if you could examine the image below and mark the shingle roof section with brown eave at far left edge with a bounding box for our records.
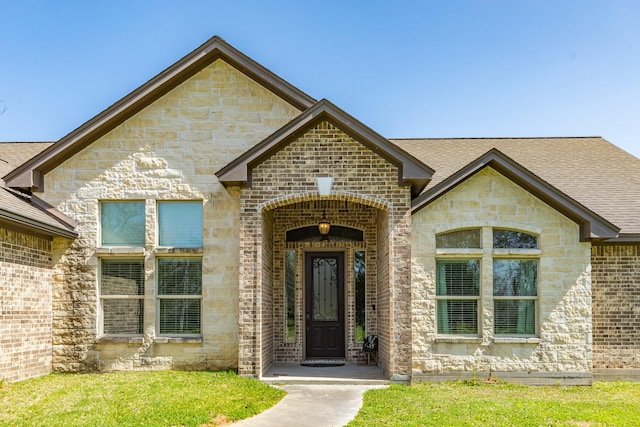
[0,142,75,237]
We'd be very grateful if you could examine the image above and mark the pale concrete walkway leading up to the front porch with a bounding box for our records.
[233,384,386,427]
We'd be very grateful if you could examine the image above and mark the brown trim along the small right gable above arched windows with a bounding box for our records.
[411,148,620,242]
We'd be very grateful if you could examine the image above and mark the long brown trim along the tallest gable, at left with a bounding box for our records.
[4,36,315,191]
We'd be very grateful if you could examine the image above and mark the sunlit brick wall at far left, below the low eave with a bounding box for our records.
[0,227,53,381]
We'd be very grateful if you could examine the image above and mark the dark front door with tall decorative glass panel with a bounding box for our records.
[305,252,345,359]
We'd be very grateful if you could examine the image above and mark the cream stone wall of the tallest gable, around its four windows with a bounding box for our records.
[40,60,299,371]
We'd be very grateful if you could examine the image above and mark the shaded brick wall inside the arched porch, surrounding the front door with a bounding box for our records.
[272,200,377,362]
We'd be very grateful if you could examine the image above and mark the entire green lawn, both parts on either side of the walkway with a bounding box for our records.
[5,371,640,427]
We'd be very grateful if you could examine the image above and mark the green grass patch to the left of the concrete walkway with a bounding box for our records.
[0,371,285,427]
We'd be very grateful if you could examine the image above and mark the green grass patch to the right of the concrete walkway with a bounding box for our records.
[349,380,640,427]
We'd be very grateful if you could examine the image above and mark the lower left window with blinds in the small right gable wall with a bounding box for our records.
[436,260,480,335]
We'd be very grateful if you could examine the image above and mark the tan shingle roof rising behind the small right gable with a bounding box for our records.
[391,137,640,234]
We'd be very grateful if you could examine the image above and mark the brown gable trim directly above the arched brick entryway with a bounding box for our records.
[216,99,434,197]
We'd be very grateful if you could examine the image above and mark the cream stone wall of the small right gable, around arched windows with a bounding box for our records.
[412,168,592,383]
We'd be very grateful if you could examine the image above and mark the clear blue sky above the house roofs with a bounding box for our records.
[0,0,640,159]
